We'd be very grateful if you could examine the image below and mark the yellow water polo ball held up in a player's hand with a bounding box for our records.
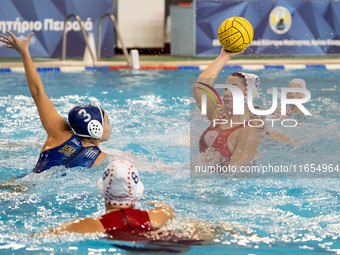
[218,17,254,52]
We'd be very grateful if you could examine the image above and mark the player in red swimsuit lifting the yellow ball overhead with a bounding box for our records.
[194,49,259,166]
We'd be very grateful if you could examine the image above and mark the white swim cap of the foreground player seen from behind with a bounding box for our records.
[98,160,144,206]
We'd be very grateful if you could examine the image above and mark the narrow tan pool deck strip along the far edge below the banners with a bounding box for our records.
[0,55,340,68]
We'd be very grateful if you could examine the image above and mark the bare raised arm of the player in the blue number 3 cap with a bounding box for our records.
[0,31,70,138]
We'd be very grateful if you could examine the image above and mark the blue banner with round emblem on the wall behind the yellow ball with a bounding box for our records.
[196,0,340,56]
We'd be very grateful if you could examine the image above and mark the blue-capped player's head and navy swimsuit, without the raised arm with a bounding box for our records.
[33,104,111,173]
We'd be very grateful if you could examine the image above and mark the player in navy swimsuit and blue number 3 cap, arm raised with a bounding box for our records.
[0,31,111,173]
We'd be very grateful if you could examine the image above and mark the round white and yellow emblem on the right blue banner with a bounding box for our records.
[269,6,292,34]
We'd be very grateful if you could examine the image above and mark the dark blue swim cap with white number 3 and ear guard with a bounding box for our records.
[68,104,104,138]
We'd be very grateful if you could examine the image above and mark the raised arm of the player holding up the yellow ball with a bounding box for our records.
[194,48,239,120]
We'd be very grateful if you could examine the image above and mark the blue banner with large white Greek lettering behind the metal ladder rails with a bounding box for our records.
[0,0,114,58]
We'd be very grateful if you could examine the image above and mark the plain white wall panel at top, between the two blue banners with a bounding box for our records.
[117,0,165,48]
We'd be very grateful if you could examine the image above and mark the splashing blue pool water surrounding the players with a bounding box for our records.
[0,69,340,254]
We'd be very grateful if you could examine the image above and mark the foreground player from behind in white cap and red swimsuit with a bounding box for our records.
[37,160,174,238]
